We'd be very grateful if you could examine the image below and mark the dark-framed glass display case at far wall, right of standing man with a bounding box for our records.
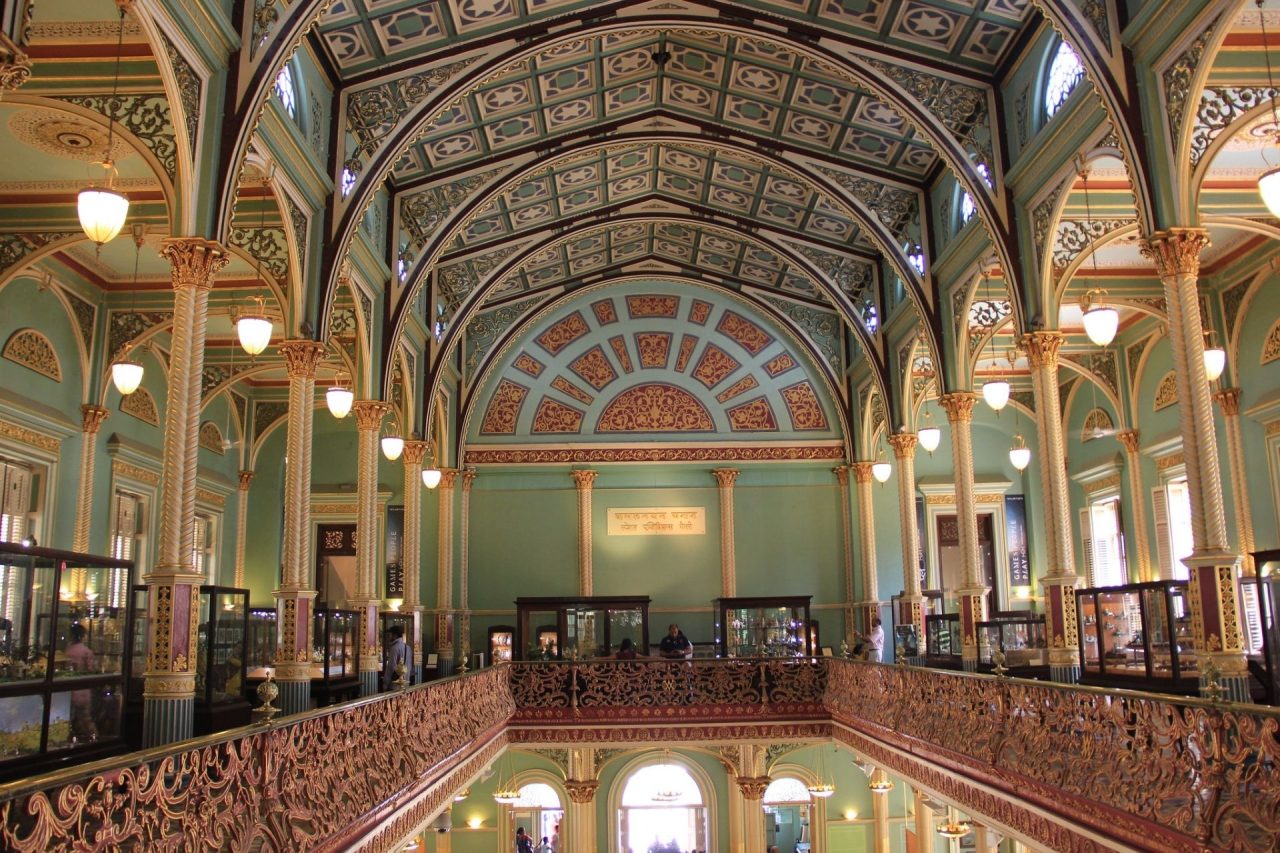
[716,596,817,657]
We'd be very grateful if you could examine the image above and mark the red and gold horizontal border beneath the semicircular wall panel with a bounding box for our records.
[466,442,845,466]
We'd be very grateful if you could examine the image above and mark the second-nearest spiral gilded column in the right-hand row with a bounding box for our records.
[1023,332,1080,684]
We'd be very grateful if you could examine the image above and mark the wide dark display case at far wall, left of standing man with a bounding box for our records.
[512,596,649,661]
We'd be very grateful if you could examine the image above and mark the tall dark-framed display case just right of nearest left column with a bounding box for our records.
[195,587,252,735]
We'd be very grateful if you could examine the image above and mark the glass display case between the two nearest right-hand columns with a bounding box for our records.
[1075,580,1199,695]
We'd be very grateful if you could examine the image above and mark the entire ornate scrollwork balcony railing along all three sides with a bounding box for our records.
[0,658,1280,853]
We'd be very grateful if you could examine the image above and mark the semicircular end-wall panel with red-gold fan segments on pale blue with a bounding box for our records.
[468,283,838,447]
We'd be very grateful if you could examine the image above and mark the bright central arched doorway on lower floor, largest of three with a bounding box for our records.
[616,756,710,853]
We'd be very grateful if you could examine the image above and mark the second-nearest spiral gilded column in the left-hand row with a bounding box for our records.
[274,338,324,713]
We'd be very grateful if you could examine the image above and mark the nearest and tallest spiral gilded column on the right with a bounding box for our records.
[1142,228,1251,702]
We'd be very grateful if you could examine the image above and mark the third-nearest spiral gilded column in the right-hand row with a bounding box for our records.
[938,391,987,671]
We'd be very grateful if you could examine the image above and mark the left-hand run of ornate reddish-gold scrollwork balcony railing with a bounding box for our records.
[0,669,515,852]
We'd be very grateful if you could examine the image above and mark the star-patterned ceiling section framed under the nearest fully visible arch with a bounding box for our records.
[393,28,937,184]
